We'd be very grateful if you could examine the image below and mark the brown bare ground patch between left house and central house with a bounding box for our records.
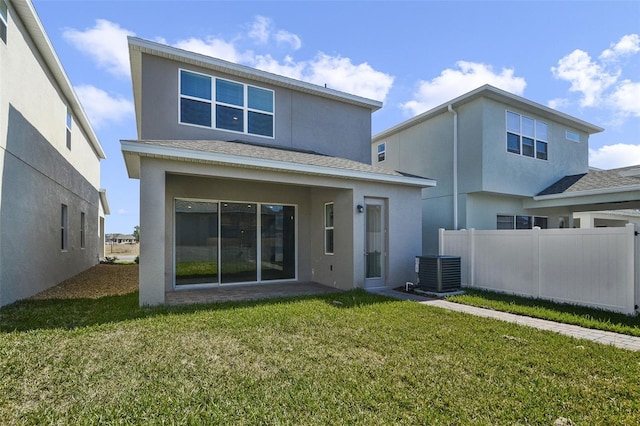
[32,264,138,300]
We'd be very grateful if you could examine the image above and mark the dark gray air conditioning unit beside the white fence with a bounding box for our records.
[416,255,460,293]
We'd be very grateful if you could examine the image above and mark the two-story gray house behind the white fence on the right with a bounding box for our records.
[371,85,640,254]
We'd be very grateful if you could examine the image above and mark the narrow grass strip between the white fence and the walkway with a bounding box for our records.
[447,288,640,336]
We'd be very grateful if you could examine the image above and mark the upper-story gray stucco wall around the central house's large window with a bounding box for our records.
[139,54,371,163]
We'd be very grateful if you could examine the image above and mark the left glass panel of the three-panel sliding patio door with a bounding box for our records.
[175,200,218,286]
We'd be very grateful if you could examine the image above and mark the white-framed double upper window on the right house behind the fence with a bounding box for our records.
[507,111,549,160]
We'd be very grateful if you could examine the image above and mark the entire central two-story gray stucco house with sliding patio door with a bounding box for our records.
[121,38,435,305]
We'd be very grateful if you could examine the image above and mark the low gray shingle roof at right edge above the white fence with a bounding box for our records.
[537,166,640,196]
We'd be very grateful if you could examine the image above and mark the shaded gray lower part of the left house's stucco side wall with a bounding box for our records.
[0,106,99,305]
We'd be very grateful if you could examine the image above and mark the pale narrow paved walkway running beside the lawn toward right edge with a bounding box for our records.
[370,288,640,351]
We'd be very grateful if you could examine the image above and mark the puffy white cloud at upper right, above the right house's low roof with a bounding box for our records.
[550,34,640,122]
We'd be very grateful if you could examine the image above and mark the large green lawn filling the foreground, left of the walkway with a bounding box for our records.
[0,291,640,425]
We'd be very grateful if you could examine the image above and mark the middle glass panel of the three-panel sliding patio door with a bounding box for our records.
[220,203,258,283]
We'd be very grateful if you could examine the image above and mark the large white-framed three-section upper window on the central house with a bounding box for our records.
[180,70,274,137]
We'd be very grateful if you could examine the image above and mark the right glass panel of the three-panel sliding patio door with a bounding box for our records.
[261,205,296,281]
